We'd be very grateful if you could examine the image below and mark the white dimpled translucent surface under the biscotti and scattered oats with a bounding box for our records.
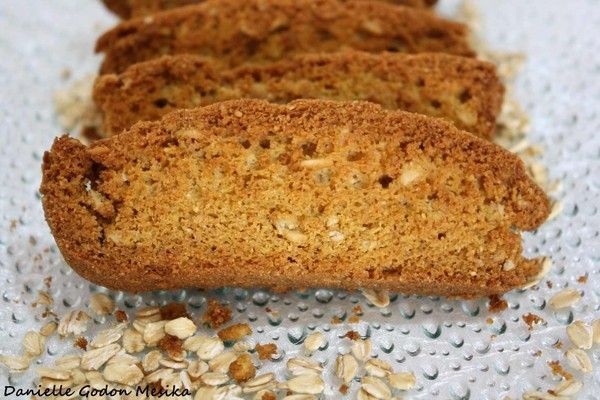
[0,0,600,399]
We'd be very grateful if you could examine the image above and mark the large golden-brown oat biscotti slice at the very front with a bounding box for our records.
[41,100,549,297]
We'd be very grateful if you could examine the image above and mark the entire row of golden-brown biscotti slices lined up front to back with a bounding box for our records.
[41,0,549,298]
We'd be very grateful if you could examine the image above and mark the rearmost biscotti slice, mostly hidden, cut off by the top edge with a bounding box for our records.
[102,0,437,19]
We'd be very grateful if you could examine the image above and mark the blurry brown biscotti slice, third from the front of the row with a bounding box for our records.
[96,0,473,73]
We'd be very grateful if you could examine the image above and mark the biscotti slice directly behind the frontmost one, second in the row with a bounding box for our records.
[94,51,504,139]
